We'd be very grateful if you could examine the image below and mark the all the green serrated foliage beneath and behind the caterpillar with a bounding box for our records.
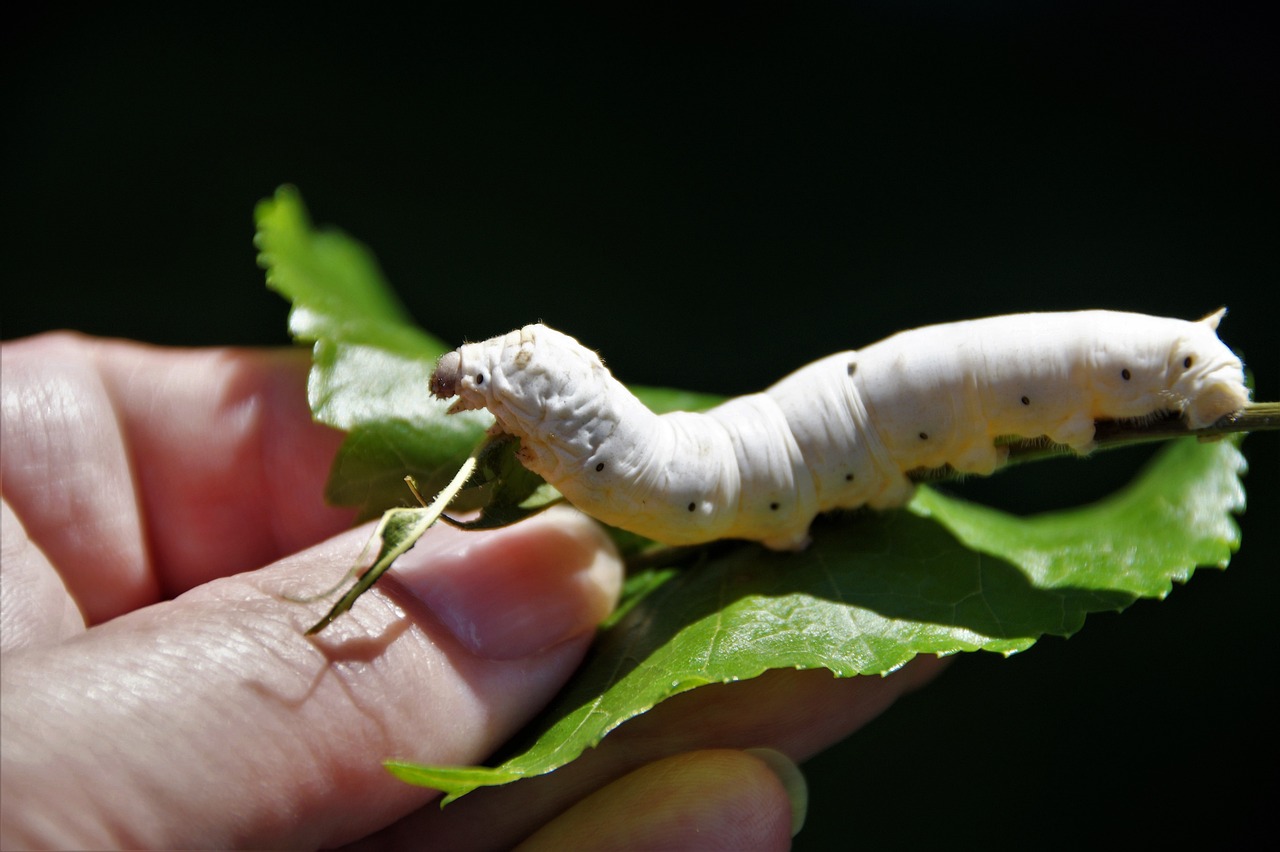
[259,191,1244,801]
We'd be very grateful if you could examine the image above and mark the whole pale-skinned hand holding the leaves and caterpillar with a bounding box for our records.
[0,334,940,849]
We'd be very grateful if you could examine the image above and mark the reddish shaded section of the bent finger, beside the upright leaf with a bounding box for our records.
[95,335,355,592]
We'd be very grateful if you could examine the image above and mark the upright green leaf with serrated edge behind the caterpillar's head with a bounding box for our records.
[255,187,493,518]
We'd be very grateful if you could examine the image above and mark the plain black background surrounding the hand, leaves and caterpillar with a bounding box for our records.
[0,0,1280,849]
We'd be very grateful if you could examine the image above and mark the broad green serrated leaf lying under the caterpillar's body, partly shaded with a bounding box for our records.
[388,440,1244,802]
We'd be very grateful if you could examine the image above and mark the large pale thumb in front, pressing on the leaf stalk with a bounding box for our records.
[0,501,621,848]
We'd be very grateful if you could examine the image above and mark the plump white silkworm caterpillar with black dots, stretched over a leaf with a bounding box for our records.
[431,308,1249,550]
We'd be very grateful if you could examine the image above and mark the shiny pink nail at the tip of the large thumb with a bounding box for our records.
[394,507,622,660]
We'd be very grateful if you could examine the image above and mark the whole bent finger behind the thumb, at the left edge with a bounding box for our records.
[3,334,352,623]
